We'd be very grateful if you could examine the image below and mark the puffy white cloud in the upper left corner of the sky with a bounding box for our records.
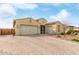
[0,4,16,16]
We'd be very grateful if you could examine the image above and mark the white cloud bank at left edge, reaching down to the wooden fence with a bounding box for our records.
[0,4,16,28]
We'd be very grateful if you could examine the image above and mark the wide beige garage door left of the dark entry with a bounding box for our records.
[20,25,38,35]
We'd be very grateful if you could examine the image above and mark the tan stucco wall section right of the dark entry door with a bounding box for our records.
[46,23,66,34]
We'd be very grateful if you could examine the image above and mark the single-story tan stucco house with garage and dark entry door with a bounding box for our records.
[13,18,77,35]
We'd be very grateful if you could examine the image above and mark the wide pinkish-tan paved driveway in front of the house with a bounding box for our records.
[0,35,79,55]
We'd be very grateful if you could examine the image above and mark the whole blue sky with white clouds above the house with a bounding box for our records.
[0,3,79,28]
